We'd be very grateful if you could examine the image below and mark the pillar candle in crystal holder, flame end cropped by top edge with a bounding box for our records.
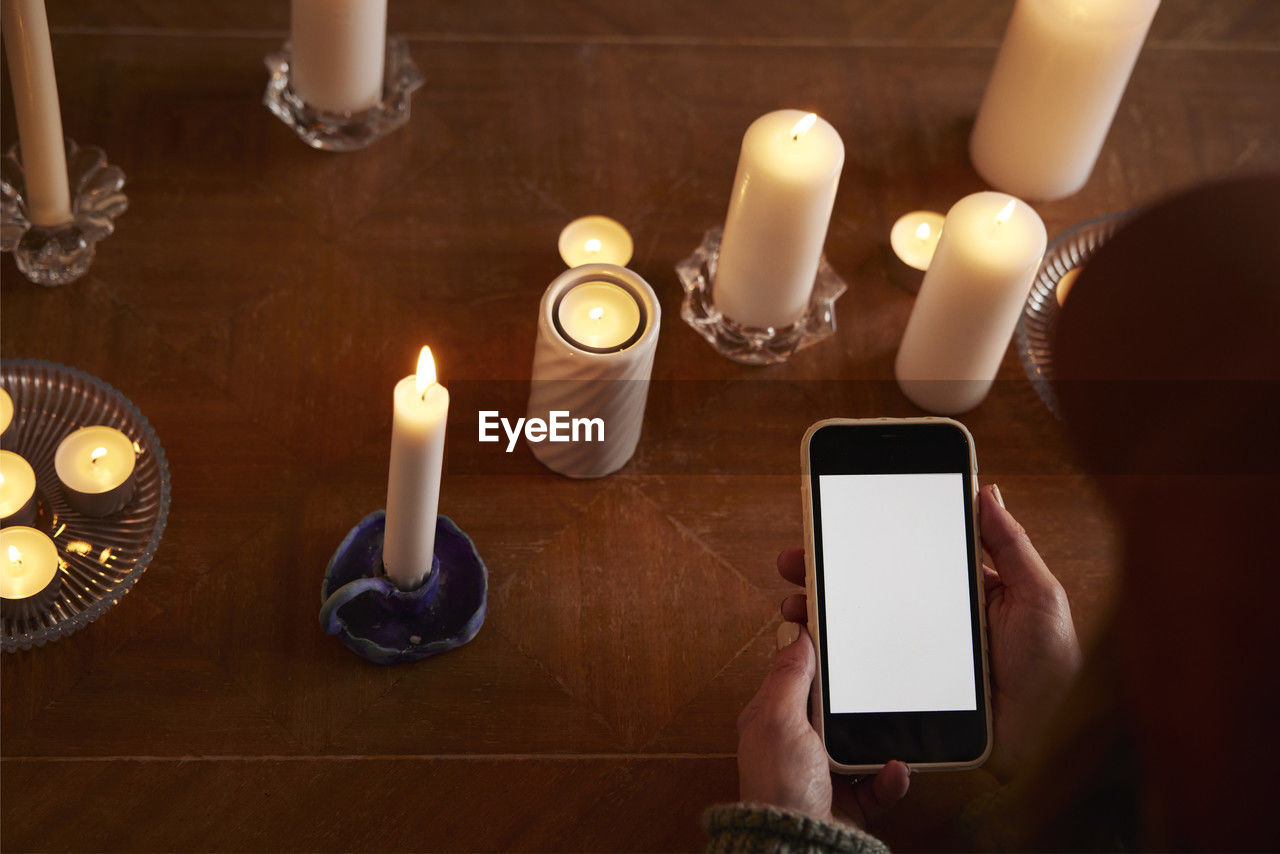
[289,0,387,113]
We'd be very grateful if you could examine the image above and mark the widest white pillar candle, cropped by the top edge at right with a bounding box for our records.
[969,0,1160,200]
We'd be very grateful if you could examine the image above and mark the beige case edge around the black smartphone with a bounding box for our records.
[800,417,992,773]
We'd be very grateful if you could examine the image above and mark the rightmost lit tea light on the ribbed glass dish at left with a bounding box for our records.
[54,425,137,516]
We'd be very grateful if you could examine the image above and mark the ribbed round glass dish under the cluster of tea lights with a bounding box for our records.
[0,359,169,652]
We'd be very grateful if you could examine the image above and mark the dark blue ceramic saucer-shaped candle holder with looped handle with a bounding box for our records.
[320,510,489,665]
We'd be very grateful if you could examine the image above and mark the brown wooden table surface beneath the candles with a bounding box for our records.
[0,0,1280,850]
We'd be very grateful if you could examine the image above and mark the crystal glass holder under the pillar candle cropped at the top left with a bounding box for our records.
[262,37,424,151]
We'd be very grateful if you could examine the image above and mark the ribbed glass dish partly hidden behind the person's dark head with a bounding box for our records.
[1015,211,1129,417]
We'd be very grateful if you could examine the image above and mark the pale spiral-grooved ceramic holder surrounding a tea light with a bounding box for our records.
[527,264,662,478]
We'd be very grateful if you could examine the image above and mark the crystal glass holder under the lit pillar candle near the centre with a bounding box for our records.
[676,227,849,365]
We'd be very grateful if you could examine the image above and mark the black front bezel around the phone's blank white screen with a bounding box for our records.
[808,423,988,766]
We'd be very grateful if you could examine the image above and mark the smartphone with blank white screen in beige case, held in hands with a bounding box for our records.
[801,417,991,773]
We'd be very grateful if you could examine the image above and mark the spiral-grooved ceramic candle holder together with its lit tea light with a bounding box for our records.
[526,264,662,478]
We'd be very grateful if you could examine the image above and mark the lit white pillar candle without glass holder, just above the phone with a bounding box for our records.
[895,192,1047,415]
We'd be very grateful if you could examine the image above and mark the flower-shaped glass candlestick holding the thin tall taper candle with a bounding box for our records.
[0,140,129,287]
